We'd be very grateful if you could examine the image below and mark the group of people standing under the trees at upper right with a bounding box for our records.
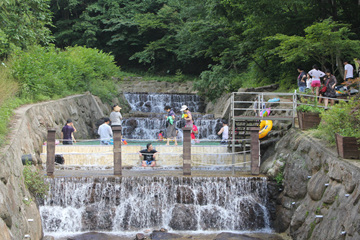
[297,60,354,109]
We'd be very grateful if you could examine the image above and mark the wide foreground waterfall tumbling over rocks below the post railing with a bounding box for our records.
[40,176,270,233]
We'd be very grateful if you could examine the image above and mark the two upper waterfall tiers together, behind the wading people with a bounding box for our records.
[122,93,222,139]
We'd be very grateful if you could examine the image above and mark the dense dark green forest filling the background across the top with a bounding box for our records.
[0,0,360,100]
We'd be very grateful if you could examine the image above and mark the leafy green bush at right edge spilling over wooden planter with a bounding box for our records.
[318,97,360,144]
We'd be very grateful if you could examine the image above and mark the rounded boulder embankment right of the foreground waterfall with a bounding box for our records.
[261,129,360,240]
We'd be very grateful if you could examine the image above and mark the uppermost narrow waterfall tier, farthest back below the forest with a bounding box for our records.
[124,93,205,113]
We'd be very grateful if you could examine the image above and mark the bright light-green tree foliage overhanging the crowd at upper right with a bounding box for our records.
[267,18,360,74]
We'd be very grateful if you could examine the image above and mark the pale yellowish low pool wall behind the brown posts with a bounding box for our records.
[40,145,250,170]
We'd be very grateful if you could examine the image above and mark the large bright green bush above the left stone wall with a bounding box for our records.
[11,46,119,102]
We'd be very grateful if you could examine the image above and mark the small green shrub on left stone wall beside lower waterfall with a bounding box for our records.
[23,164,49,198]
